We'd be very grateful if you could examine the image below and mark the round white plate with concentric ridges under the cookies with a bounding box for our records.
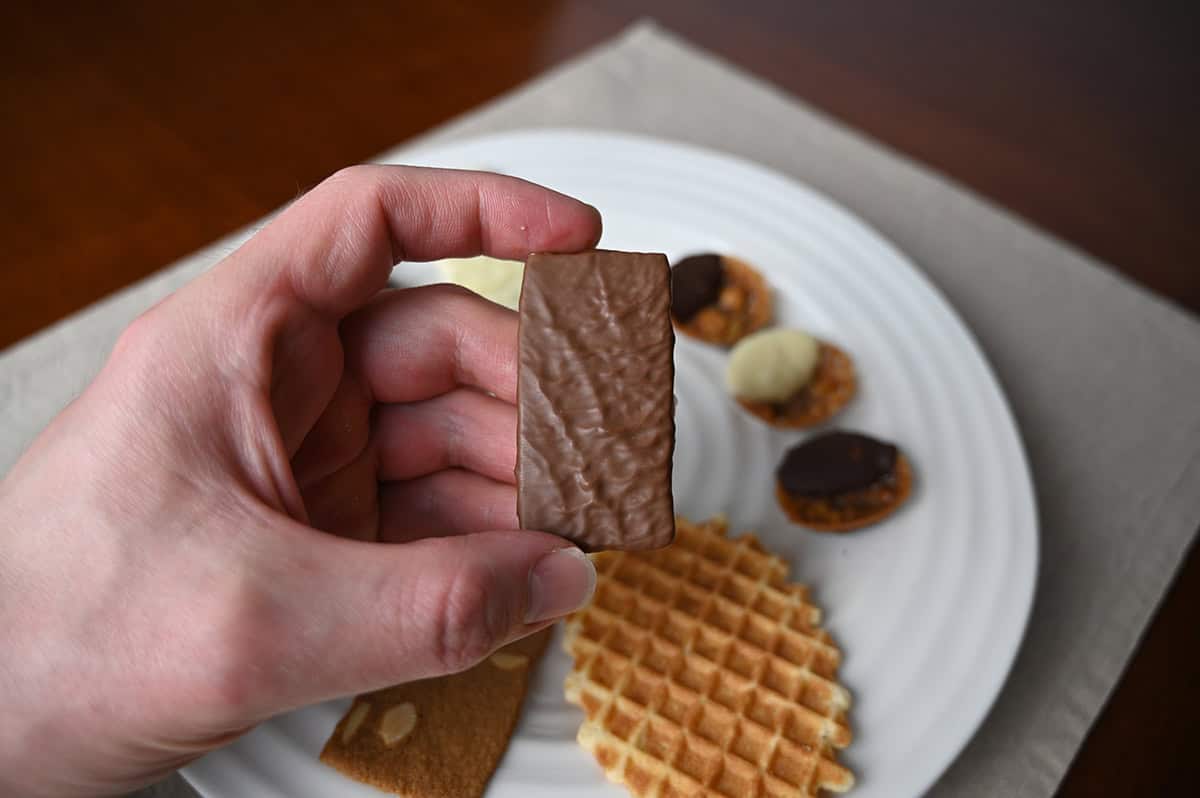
[185,131,1038,798]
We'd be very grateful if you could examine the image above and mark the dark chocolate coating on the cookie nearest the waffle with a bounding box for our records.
[775,431,896,496]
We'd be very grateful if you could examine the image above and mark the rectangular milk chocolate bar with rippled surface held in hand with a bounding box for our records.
[516,250,674,551]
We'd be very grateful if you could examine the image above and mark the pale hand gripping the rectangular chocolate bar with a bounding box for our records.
[0,167,600,796]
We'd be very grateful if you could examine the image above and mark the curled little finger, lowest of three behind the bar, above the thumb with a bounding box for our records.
[379,469,517,542]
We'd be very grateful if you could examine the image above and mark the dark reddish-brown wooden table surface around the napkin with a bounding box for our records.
[0,0,1200,797]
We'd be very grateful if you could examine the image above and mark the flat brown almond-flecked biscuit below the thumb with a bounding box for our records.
[320,629,551,798]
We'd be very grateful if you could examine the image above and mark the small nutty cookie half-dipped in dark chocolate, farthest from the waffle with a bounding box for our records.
[671,252,772,347]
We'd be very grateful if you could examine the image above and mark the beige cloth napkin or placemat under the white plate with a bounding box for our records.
[0,18,1200,798]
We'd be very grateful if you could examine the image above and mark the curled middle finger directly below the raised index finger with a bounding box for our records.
[342,286,517,402]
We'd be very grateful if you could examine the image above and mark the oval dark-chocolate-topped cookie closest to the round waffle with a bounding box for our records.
[775,430,913,532]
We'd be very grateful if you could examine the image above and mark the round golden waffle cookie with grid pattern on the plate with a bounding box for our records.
[565,517,854,798]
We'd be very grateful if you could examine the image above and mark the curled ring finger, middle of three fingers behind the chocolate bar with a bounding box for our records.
[374,389,517,484]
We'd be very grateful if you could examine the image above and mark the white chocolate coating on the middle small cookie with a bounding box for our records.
[725,328,821,402]
